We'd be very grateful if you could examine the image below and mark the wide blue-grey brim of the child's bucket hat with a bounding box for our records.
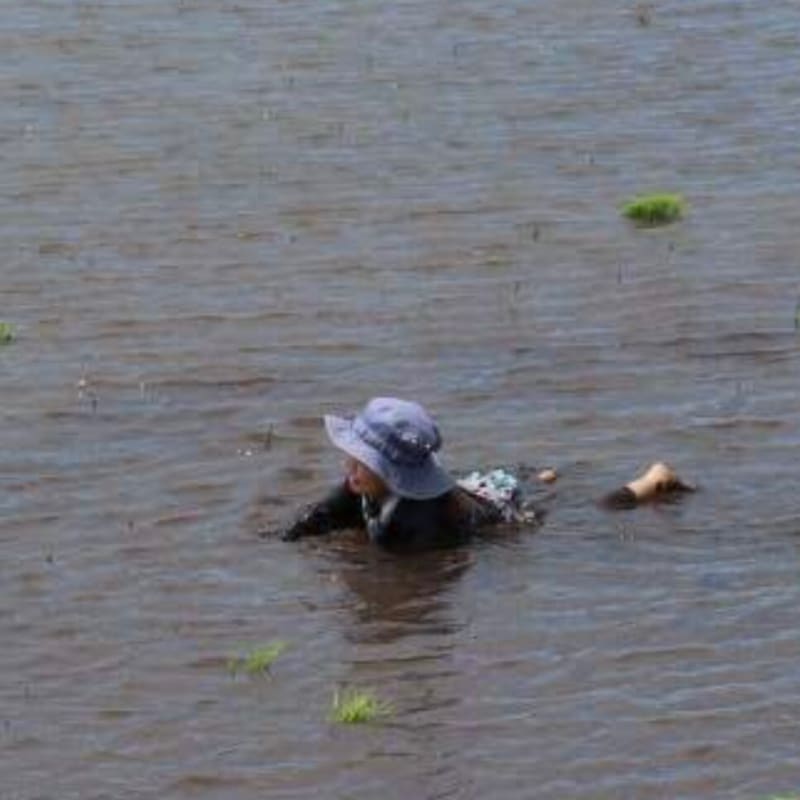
[324,414,456,500]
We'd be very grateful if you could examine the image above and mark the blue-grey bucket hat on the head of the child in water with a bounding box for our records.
[325,397,455,500]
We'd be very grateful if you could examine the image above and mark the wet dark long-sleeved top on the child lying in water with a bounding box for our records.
[281,483,502,550]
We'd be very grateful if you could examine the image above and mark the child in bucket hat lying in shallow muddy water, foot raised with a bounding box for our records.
[270,397,691,549]
